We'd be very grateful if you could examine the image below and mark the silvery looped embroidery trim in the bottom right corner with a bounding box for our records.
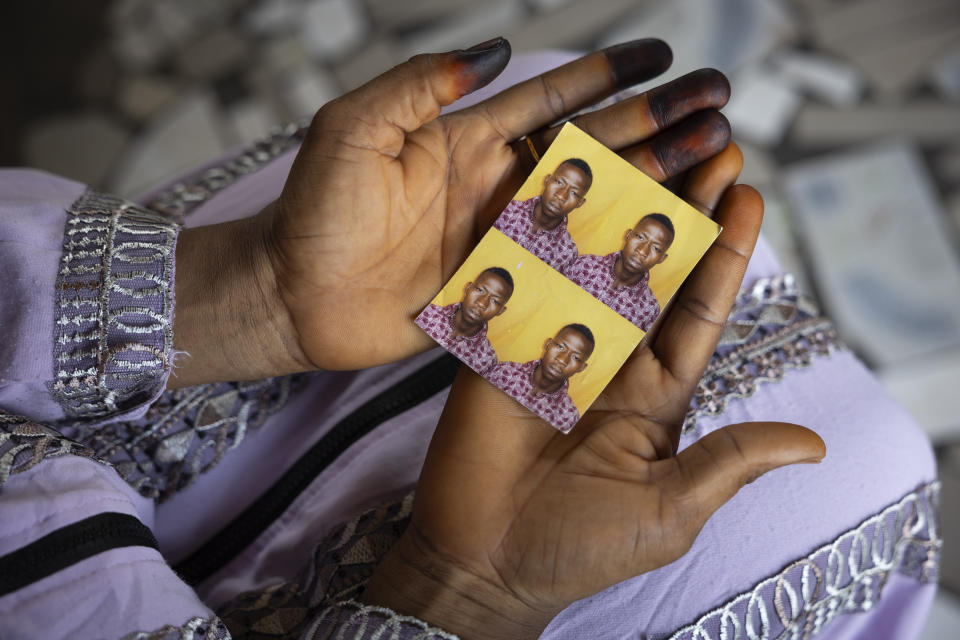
[669,482,943,640]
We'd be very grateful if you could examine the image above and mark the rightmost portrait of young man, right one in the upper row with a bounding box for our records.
[564,213,676,331]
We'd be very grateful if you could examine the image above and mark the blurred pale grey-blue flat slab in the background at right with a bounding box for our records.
[783,142,960,367]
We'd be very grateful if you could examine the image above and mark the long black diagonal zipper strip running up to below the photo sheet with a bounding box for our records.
[174,354,460,585]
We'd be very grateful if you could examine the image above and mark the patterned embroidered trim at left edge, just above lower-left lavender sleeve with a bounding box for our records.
[0,412,107,489]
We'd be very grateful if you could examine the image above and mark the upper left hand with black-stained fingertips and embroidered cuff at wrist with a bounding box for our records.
[171,40,729,386]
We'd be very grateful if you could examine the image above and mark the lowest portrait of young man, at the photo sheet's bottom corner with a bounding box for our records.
[487,324,596,433]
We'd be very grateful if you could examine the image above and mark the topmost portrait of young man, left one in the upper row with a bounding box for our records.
[493,158,593,271]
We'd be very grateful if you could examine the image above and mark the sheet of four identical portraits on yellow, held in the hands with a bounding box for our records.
[416,123,720,433]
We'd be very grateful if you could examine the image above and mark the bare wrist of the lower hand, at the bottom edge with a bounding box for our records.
[361,525,559,640]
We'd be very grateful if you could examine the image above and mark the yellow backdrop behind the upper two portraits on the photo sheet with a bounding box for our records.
[514,123,720,308]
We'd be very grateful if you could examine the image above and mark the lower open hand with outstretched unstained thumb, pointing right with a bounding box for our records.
[364,145,825,640]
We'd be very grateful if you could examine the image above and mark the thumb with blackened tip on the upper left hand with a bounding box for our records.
[327,37,510,144]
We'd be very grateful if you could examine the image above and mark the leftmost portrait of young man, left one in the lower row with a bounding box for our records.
[416,267,513,375]
